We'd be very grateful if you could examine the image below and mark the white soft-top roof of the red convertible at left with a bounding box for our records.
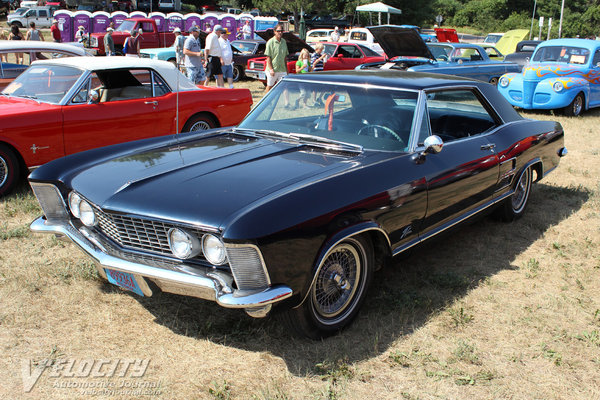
[32,57,200,90]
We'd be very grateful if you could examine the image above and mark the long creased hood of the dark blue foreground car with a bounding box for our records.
[71,131,362,229]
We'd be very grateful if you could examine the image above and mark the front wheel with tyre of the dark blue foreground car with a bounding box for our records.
[283,236,374,339]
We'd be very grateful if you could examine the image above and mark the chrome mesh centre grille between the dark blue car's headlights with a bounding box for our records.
[95,207,186,256]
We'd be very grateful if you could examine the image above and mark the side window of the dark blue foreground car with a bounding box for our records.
[426,89,497,142]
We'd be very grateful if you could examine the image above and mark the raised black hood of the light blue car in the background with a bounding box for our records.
[368,25,435,60]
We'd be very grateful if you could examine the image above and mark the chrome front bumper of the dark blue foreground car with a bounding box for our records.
[30,217,292,310]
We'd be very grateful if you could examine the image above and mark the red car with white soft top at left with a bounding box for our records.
[0,57,252,196]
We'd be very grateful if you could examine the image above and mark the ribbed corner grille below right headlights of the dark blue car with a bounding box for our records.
[227,246,271,290]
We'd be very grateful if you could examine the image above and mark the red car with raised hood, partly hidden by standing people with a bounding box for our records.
[246,29,386,82]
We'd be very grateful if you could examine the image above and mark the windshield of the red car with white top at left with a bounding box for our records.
[2,65,83,104]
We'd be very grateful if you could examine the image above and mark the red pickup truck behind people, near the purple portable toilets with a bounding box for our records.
[89,18,175,55]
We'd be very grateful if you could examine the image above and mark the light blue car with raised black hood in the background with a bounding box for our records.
[357,25,520,85]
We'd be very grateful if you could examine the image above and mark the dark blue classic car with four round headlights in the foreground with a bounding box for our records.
[29,71,566,338]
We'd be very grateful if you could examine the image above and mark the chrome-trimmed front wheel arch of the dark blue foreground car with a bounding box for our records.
[294,221,392,308]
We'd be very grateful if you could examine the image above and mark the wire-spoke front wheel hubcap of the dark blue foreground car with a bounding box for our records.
[312,243,363,323]
